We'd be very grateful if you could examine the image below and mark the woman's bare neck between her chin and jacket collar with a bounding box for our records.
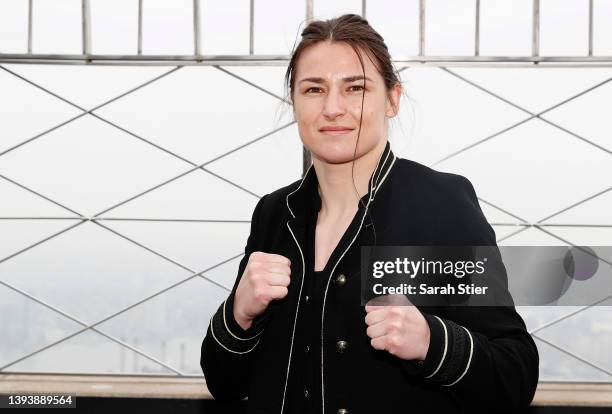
[313,140,387,218]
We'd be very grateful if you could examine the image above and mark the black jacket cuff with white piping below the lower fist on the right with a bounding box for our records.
[406,313,474,386]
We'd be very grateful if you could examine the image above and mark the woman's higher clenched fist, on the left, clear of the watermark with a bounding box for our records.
[233,252,291,330]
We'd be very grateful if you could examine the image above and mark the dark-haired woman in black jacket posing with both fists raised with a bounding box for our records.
[201,14,538,414]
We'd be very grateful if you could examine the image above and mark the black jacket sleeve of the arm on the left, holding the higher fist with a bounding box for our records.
[200,196,268,400]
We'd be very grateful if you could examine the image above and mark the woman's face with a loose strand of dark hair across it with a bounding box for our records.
[293,41,401,164]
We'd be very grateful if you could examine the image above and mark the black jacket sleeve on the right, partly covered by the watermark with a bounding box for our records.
[405,175,539,413]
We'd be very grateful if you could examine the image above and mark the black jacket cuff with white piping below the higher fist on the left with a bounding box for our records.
[210,292,268,354]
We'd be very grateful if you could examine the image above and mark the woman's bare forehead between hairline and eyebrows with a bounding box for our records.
[295,41,380,81]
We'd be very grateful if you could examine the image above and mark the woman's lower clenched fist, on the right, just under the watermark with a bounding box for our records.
[365,295,431,361]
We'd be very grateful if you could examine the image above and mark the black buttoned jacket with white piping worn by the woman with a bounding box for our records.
[201,143,539,414]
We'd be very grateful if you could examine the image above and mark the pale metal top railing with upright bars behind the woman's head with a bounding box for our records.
[0,0,612,67]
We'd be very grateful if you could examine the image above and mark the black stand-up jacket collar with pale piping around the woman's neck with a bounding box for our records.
[286,141,396,218]
